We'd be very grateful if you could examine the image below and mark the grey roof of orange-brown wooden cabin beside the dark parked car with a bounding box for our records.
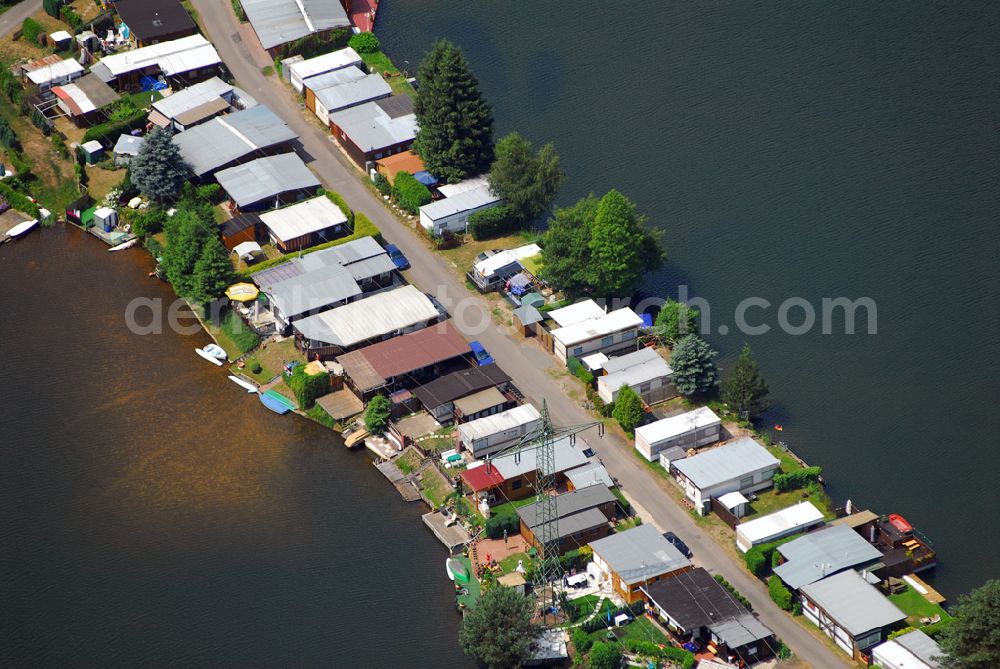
[590,525,691,584]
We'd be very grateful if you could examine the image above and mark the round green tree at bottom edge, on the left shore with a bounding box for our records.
[458,586,538,669]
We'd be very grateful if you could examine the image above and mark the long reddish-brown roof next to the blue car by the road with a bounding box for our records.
[337,321,469,391]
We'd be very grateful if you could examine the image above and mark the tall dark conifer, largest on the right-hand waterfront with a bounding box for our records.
[413,39,493,183]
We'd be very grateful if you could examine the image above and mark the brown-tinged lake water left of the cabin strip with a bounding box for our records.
[0,226,473,669]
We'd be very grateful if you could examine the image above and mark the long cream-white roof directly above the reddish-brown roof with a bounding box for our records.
[295,286,438,347]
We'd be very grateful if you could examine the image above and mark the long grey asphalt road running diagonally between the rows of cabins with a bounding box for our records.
[188,0,848,669]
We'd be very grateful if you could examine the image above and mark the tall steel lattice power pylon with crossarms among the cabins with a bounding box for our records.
[494,401,604,620]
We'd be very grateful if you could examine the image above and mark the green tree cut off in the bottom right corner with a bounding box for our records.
[938,579,1000,669]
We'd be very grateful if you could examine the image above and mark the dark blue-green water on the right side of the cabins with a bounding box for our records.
[376,0,1000,595]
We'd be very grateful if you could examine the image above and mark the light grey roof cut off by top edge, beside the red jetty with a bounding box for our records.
[241,0,351,49]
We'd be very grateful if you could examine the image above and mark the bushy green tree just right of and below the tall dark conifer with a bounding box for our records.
[490,132,566,226]
